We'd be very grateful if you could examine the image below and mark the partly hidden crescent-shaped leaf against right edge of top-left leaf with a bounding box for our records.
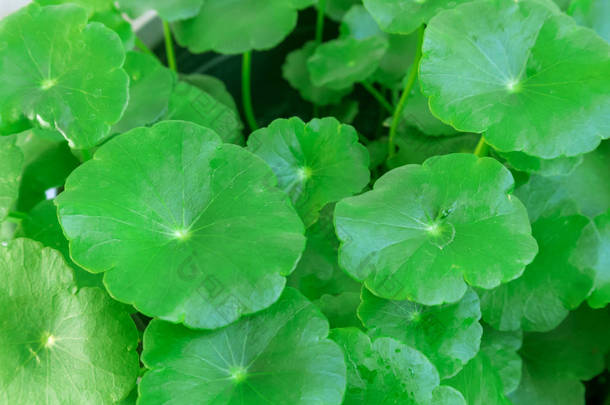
[112,51,174,133]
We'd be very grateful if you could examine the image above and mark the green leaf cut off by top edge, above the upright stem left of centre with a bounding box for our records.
[174,0,298,54]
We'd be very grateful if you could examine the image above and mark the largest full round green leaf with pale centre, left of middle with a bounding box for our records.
[55,122,305,328]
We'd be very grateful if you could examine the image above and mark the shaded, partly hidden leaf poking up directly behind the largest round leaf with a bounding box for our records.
[163,82,244,145]
